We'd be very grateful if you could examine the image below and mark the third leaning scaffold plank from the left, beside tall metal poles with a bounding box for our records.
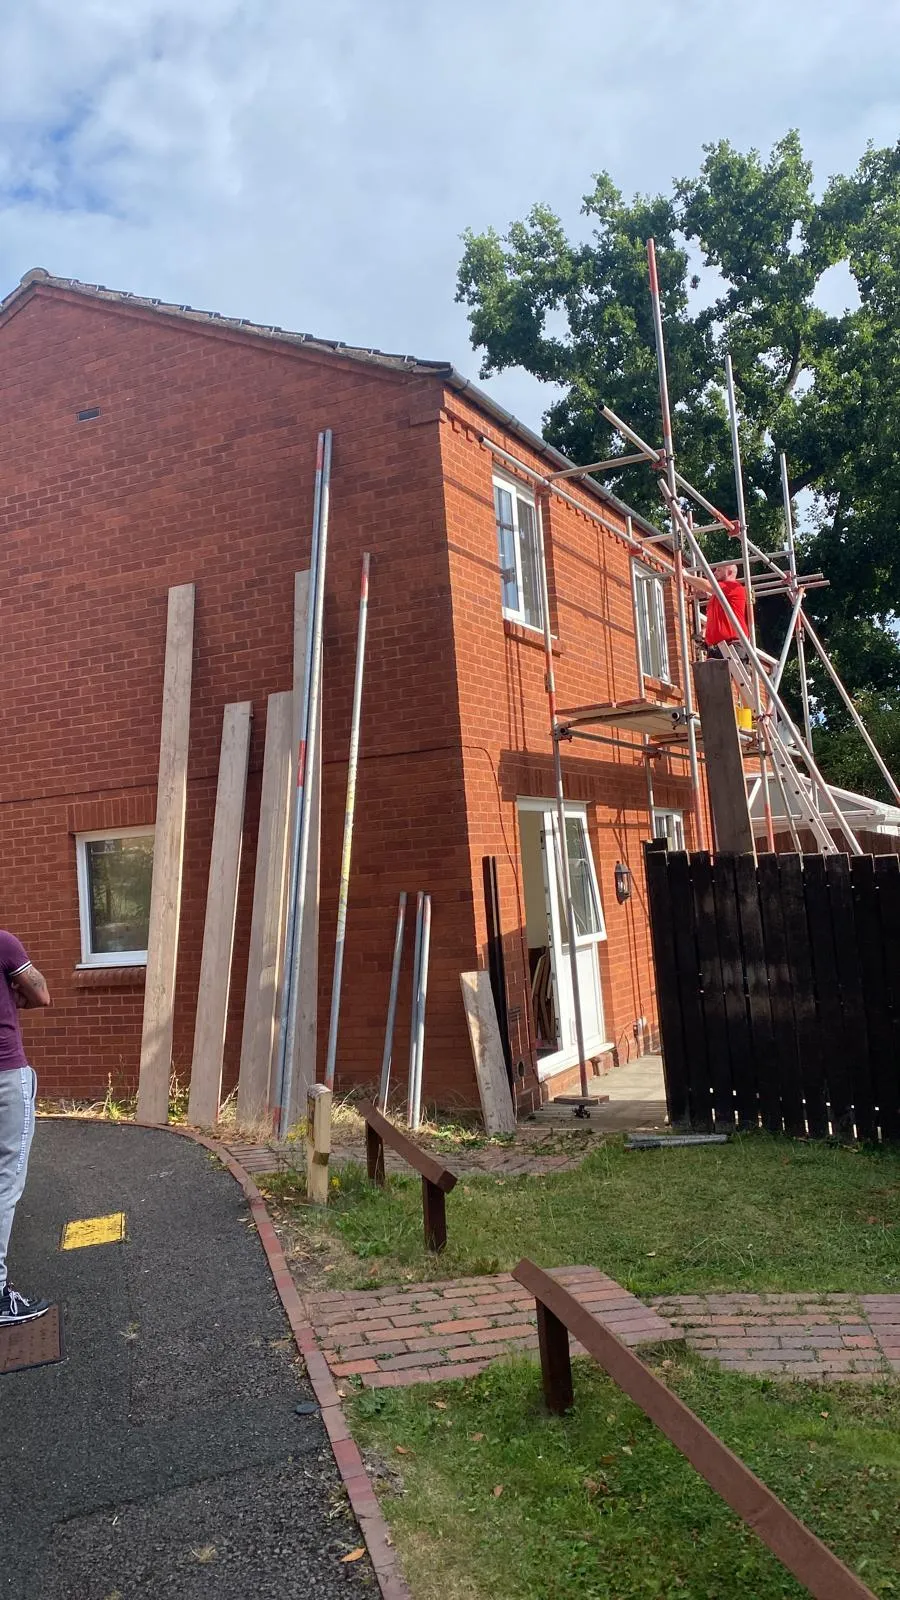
[237,690,293,1123]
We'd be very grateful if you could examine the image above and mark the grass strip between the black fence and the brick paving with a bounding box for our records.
[264,1134,900,1298]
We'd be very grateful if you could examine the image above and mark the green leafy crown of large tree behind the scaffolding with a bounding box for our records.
[458,133,900,796]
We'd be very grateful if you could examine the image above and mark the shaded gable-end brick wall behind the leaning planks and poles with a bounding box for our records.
[0,285,472,1098]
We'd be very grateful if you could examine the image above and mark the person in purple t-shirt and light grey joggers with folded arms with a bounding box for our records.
[0,928,50,1326]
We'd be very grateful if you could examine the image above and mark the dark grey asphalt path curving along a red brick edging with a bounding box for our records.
[0,1122,376,1600]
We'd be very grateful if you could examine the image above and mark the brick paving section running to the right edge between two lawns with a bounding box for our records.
[652,1293,900,1382]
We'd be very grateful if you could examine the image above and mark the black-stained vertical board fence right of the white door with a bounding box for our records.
[645,842,900,1139]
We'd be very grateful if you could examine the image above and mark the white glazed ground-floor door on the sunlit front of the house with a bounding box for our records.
[528,805,607,1077]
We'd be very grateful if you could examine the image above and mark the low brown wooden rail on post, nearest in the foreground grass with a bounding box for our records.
[512,1259,874,1600]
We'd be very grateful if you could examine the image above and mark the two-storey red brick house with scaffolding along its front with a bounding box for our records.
[0,270,689,1104]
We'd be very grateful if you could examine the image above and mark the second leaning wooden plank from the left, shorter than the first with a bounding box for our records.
[187,701,253,1128]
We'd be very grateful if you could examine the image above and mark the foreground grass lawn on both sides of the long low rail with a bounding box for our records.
[349,1355,900,1600]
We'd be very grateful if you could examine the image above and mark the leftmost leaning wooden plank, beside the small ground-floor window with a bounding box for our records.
[136,584,194,1125]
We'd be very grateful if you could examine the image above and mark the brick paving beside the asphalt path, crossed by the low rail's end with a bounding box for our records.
[304,1267,681,1389]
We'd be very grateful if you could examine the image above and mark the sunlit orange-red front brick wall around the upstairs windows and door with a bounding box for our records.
[440,392,690,1096]
